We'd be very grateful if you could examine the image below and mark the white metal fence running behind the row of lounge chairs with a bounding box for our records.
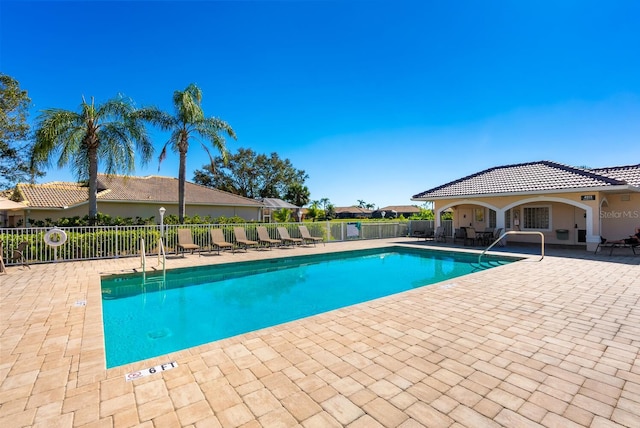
[0,220,450,265]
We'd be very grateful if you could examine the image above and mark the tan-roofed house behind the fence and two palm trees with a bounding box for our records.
[2,174,262,227]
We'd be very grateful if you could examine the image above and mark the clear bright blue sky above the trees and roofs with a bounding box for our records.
[0,0,640,207]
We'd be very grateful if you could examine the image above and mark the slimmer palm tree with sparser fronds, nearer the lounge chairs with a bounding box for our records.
[142,83,236,223]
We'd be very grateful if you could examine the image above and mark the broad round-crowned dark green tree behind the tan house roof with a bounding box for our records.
[193,148,309,201]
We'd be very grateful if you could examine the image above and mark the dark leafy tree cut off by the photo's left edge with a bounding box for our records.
[0,73,41,189]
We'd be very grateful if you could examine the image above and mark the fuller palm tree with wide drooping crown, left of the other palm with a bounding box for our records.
[30,95,153,224]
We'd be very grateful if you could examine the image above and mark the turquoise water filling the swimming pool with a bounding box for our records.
[102,247,518,368]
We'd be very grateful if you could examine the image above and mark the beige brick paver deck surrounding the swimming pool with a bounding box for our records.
[0,239,640,428]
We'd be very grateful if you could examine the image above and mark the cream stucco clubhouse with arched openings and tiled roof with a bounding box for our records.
[412,161,640,251]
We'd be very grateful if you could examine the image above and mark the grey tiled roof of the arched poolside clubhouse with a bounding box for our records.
[413,161,640,200]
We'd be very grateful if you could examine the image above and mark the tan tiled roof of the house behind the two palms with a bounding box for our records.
[16,174,262,208]
